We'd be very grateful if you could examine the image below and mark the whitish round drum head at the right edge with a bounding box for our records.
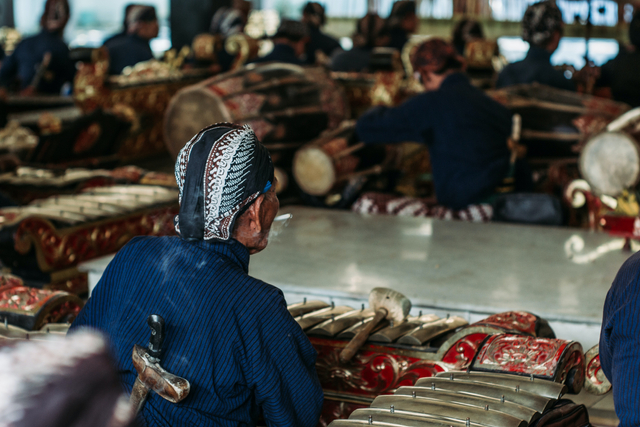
[580,132,640,197]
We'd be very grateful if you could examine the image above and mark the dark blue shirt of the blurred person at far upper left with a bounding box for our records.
[0,30,76,94]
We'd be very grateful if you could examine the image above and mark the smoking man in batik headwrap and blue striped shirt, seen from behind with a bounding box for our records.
[71,124,323,427]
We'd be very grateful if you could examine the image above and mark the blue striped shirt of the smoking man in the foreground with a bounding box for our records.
[71,237,323,427]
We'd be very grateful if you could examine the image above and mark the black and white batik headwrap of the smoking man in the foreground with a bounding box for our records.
[175,123,273,241]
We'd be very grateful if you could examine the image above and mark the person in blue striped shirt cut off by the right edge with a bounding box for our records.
[600,252,640,427]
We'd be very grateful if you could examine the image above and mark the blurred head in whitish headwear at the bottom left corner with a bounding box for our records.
[0,331,133,427]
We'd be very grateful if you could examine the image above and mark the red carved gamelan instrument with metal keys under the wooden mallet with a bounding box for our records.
[288,299,601,426]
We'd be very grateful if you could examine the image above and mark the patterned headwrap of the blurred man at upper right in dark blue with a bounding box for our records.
[522,0,563,47]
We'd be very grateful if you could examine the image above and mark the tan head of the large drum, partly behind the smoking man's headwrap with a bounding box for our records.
[164,85,231,158]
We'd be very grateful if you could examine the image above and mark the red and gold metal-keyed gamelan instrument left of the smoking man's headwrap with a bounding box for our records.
[0,184,179,293]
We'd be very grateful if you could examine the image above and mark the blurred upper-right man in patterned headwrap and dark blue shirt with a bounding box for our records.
[496,0,576,90]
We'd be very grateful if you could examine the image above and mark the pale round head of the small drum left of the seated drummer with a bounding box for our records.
[293,146,336,196]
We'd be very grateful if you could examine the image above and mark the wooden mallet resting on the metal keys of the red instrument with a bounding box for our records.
[340,288,411,363]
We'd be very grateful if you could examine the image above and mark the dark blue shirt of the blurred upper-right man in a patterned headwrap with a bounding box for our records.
[496,46,576,90]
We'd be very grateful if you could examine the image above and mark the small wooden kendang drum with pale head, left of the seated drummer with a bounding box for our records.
[293,121,399,204]
